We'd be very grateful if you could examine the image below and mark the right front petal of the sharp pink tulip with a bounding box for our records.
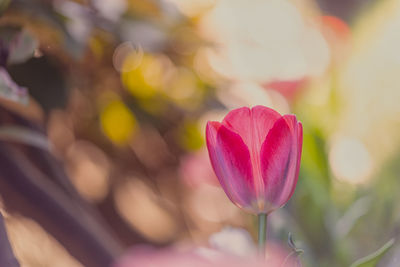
[260,116,297,212]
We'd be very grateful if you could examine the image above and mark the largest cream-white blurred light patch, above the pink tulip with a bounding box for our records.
[201,0,330,82]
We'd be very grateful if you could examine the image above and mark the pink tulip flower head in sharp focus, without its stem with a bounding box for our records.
[206,106,303,214]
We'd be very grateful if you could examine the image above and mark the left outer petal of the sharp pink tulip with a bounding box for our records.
[206,122,254,209]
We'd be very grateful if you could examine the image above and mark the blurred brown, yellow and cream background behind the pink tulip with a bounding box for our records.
[0,0,400,267]
